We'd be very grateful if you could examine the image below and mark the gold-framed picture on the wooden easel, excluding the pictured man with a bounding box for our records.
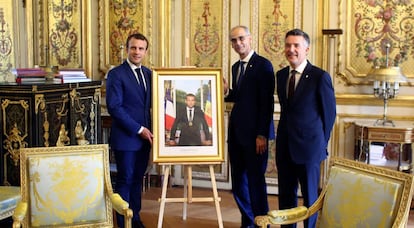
[152,68,224,164]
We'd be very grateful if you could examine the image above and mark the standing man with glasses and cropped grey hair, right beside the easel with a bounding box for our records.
[224,26,275,227]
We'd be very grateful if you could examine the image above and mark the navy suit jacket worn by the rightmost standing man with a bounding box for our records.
[276,62,336,164]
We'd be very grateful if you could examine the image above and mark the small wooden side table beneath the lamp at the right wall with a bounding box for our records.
[354,121,414,173]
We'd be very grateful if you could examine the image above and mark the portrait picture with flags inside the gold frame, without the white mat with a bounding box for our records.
[165,80,212,146]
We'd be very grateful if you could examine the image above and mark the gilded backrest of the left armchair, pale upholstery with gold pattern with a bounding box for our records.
[20,144,113,227]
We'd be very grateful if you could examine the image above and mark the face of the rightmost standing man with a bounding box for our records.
[285,36,309,68]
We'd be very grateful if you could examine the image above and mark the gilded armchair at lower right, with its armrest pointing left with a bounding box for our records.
[255,158,414,228]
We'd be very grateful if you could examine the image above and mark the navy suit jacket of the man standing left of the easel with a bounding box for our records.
[106,61,151,151]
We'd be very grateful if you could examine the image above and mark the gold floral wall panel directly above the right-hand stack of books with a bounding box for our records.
[32,0,85,68]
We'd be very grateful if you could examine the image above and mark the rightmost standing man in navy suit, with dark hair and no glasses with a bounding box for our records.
[276,29,336,227]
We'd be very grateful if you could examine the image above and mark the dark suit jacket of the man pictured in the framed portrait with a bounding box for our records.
[170,106,211,146]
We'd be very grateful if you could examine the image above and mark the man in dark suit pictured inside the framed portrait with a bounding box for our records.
[169,93,211,146]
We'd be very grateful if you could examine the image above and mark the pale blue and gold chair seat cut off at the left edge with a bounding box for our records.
[0,186,20,220]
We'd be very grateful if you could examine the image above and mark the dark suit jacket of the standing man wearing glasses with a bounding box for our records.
[225,53,275,146]
